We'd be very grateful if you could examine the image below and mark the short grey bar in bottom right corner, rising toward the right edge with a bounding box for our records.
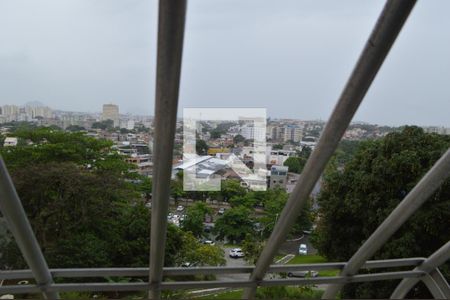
[391,241,450,299]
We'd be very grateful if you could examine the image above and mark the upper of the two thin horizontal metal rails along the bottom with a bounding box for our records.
[0,258,425,280]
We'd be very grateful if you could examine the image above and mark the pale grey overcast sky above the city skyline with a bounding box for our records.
[0,0,450,127]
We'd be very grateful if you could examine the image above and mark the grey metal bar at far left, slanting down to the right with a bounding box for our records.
[0,158,59,299]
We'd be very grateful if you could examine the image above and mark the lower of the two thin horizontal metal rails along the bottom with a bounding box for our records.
[0,271,426,294]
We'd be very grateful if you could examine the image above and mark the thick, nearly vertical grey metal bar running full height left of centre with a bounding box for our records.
[149,0,186,299]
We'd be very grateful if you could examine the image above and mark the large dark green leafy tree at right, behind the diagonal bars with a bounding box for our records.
[313,127,450,298]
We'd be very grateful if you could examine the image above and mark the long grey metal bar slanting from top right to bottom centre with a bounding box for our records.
[243,0,416,299]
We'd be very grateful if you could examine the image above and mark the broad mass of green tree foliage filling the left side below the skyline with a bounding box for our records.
[0,128,223,268]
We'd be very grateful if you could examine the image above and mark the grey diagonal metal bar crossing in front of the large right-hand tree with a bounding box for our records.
[323,149,450,299]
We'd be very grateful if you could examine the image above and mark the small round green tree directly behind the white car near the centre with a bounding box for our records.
[214,206,254,243]
